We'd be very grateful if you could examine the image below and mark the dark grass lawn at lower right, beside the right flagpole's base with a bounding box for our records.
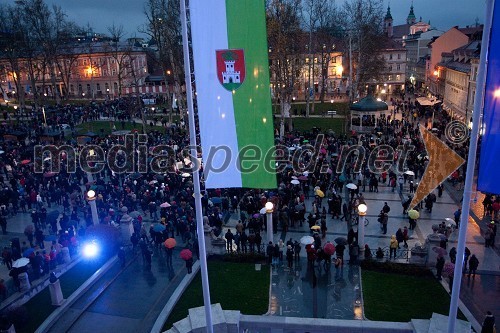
[362,269,467,322]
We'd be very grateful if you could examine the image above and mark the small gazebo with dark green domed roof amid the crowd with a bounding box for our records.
[351,94,389,133]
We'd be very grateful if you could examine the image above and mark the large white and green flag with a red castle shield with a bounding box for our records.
[189,0,276,188]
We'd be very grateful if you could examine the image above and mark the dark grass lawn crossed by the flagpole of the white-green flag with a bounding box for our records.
[162,260,270,331]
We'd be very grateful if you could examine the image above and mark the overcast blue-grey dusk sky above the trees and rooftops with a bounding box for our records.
[0,0,485,37]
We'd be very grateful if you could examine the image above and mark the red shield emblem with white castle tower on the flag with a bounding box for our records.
[215,49,245,91]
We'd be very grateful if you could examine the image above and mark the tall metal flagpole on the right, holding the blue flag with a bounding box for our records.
[448,0,495,333]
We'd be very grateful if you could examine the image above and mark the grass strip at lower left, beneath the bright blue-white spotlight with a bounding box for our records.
[11,260,103,333]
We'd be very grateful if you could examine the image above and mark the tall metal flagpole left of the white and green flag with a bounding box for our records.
[180,0,214,333]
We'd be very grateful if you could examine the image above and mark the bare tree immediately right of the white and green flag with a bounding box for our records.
[266,0,303,136]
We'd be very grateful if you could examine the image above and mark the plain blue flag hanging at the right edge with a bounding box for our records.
[477,3,500,194]
